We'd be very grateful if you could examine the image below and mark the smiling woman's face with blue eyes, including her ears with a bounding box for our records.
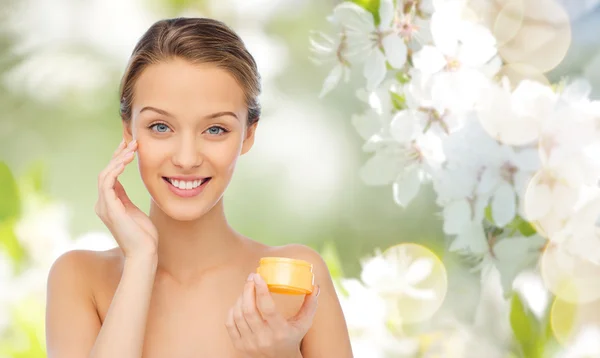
[124,59,256,221]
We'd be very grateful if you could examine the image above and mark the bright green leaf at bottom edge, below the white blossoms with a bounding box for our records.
[510,292,545,358]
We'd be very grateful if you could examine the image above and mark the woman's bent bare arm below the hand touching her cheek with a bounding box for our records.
[46,251,157,358]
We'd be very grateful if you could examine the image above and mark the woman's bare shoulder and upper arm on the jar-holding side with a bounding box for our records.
[280,245,353,358]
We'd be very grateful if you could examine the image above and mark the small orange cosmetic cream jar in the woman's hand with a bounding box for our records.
[256,257,314,295]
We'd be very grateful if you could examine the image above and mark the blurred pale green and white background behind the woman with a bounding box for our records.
[0,0,600,357]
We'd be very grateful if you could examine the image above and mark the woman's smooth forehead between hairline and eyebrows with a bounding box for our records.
[133,59,246,115]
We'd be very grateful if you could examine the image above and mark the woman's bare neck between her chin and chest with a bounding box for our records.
[149,198,242,282]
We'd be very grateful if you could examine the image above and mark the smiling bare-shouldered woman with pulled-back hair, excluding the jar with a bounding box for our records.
[46,18,352,358]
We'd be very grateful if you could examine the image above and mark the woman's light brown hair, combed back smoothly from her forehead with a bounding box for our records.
[120,17,261,125]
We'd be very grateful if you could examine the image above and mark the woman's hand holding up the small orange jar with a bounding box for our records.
[225,273,319,358]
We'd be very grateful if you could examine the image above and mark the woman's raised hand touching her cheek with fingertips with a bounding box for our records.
[95,140,158,258]
